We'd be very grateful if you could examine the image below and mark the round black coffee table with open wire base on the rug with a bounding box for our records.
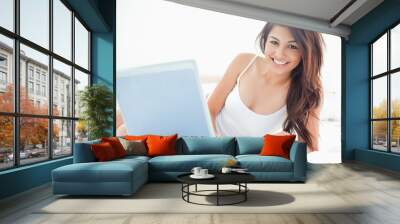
[177,173,255,206]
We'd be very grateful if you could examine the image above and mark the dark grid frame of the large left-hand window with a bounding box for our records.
[0,0,93,172]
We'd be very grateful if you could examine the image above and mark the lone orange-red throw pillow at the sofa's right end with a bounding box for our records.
[260,134,296,159]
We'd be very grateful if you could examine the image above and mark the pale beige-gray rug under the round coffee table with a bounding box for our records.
[35,183,360,214]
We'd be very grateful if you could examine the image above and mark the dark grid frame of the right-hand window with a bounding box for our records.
[368,21,400,155]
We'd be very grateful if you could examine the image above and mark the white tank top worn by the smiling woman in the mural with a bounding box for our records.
[216,55,287,137]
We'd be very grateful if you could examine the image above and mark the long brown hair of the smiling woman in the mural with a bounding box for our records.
[257,23,324,146]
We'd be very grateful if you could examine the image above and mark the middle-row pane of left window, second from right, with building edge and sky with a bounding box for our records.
[53,59,72,117]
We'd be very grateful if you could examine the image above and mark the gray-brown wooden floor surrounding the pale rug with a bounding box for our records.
[0,163,400,224]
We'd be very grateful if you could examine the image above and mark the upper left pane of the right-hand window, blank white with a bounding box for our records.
[372,34,387,75]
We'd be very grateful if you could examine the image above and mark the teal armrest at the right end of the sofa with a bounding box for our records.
[290,141,307,181]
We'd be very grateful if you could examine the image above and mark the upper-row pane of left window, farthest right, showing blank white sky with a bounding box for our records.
[75,18,89,69]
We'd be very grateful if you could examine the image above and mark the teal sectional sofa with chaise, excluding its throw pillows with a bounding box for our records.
[52,137,307,195]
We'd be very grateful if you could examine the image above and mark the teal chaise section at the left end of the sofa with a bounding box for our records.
[52,141,149,195]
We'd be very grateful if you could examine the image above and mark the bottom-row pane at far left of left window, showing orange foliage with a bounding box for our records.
[0,116,14,170]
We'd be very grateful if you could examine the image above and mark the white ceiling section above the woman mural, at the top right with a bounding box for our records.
[168,0,383,38]
